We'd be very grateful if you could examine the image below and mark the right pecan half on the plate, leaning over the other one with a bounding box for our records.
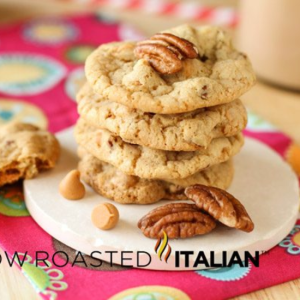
[185,184,254,232]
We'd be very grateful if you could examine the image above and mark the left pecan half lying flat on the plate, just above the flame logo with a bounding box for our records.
[138,203,216,239]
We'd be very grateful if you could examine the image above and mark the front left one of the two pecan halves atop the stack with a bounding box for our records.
[134,43,182,74]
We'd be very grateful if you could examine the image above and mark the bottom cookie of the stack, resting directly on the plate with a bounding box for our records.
[78,148,234,204]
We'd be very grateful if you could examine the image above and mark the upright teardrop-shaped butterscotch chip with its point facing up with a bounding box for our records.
[59,170,85,200]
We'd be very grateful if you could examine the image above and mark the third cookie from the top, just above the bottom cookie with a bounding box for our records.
[75,120,244,179]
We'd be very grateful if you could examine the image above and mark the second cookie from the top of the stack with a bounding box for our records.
[77,84,247,151]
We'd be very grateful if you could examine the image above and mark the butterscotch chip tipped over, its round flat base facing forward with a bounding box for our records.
[92,203,119,230]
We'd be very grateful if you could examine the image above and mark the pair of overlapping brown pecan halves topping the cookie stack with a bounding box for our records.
[134,33,198,74]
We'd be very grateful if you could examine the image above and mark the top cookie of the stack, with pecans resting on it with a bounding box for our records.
[85,25,255,114]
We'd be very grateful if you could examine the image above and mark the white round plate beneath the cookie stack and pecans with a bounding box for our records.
[24,128,299,270]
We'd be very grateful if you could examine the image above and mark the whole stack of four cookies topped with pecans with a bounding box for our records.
[75,25,255,204]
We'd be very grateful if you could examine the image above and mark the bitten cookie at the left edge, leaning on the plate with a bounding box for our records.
[0,122,60,186]
